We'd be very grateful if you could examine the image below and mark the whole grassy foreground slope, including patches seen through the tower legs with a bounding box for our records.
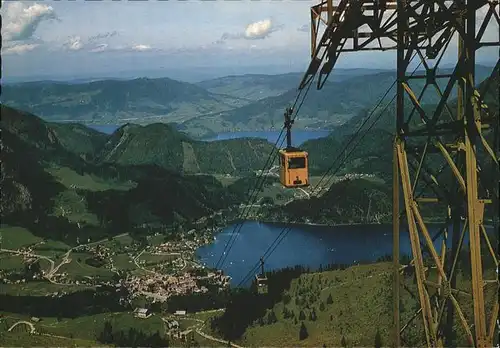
[241,263,495,347]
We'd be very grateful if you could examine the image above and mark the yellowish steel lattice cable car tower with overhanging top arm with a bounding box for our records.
[300,0,500,347]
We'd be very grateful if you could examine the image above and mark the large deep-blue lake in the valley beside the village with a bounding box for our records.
[196,221,492,285]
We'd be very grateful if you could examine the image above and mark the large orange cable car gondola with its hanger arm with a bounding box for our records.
[279,108,309,188]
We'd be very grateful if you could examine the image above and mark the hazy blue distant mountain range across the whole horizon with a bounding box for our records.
[0,66,491,137]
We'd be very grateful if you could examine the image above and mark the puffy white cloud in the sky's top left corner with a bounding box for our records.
[2,2,57,41]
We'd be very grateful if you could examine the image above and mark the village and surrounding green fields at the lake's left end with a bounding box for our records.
[0,230,230,302]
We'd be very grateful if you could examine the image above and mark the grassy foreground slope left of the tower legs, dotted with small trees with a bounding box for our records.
[243,264,392,347]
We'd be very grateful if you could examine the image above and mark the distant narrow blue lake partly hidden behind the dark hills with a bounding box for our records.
[88,124,330,146]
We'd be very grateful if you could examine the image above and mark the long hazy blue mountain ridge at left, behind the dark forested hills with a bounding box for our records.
[1,78,246,128]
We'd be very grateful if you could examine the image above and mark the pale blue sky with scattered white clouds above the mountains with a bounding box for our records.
[1,0,498,79]
